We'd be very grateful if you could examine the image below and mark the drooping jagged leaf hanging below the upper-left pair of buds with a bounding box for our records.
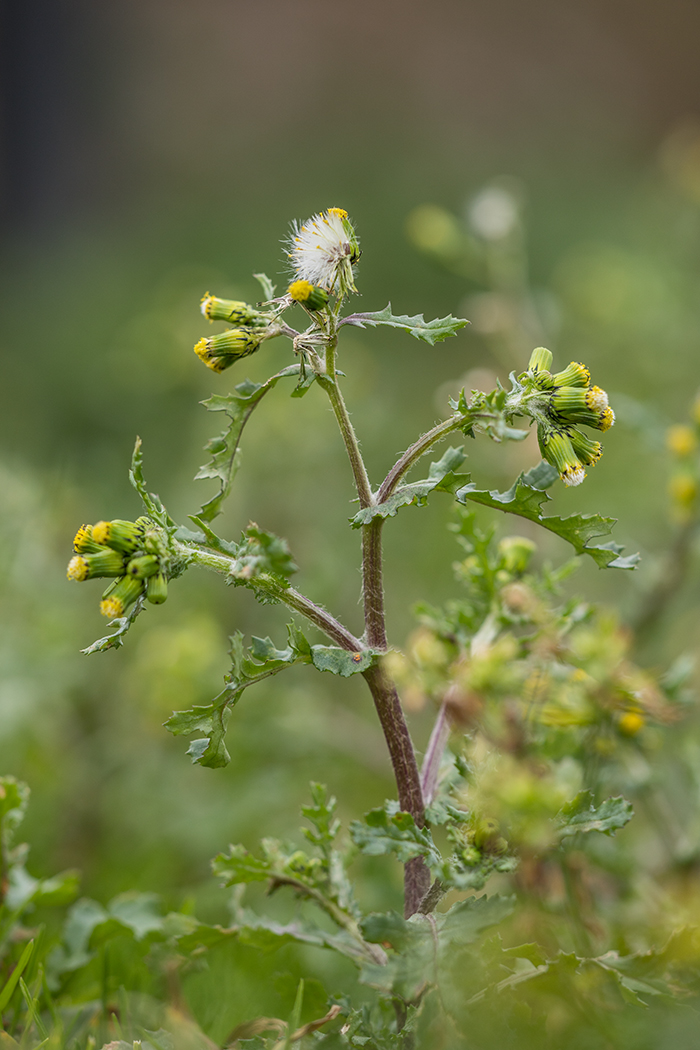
[195,365,301,522]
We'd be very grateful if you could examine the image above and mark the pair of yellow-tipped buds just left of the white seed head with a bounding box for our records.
[194,292,280,372]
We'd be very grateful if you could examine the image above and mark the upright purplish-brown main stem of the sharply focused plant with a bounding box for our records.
[319,331,430,917]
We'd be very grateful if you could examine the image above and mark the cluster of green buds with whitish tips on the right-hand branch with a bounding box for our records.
[522,347,615,485]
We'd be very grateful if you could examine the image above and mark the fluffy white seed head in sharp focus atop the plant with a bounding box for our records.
[289,208,360,295]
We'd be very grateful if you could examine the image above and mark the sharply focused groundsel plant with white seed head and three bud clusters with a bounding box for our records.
[68,208,634,915]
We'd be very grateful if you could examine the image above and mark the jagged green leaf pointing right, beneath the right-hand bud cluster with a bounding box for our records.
[454,467,639,569]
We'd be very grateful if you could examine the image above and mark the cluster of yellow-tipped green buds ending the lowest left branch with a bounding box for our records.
[67,518,168,620]
